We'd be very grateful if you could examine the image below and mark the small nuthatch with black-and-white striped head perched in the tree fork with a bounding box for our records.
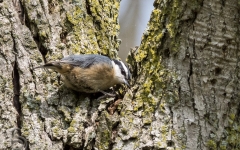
[36,54,131,94]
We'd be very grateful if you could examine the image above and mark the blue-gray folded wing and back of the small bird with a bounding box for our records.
[60,54,112,68]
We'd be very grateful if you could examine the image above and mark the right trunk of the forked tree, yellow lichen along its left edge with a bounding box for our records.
[124,0,240,150]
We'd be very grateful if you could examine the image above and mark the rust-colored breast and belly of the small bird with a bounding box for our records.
[59,64,117,93]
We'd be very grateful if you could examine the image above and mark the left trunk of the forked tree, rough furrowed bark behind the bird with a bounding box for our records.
[0,0,119,149]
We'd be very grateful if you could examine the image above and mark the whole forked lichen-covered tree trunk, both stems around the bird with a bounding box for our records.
[0,0,240,150]
